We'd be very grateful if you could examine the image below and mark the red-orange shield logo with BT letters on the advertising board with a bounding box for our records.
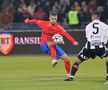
[0,34,14,55]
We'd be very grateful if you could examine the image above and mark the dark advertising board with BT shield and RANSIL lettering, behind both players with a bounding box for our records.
[0,31,85,55]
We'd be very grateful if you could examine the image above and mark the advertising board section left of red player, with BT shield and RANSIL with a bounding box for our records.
[0,32,40,55]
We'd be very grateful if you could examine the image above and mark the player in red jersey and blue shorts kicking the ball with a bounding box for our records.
[25,11,78,76]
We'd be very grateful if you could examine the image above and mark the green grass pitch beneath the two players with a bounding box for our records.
[0,55,108,90]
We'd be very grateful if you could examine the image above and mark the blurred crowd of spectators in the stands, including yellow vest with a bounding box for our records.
[0,0,108,29]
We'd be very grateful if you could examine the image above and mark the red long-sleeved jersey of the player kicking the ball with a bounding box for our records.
[28,20,75,44]
